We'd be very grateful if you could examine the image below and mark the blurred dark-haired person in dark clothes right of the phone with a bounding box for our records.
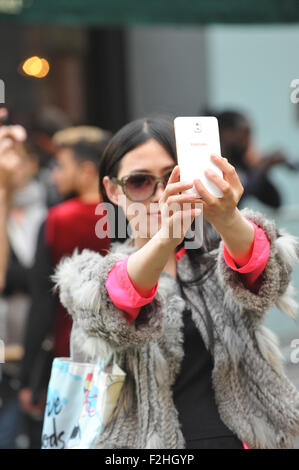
[206,110,294,209]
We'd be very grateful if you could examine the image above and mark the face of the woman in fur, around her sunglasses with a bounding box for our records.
[103,139,176,242]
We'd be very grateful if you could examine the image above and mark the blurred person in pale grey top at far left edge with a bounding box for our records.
[0,112,47,449]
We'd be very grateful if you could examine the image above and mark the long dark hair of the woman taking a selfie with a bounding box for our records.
[99,116,220,349]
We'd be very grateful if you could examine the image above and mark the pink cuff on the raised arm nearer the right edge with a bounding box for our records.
[223,220,270,292]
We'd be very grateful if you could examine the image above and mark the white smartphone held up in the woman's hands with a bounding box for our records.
[174,116,223,198]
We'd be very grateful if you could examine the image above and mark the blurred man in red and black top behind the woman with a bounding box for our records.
[19,126,110,447]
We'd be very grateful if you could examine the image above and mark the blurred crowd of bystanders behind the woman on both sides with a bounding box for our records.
[0,103,296,449]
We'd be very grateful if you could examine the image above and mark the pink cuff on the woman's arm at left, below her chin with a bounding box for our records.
[105,256,158,323]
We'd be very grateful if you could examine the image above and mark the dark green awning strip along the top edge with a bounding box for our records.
[0,0,299,26]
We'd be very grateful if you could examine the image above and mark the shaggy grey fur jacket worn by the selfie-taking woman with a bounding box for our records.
[54,208,299,449]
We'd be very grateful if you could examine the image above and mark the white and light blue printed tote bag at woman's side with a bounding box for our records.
[41,352,126,449]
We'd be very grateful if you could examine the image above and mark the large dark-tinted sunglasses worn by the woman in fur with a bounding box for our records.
[111,170,172,202]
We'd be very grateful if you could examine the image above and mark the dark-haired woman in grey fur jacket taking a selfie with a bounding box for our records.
[55,118,299,449]
